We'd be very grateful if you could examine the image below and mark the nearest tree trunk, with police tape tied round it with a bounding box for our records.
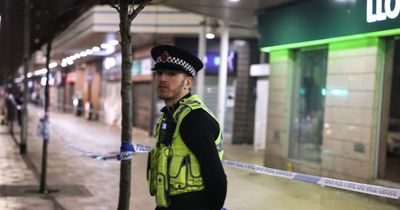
[118,0,132,210]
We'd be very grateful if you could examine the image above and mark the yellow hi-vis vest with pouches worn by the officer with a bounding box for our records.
[147,95,223,207]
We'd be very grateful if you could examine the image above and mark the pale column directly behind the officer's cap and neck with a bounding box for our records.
[196,17,207,100]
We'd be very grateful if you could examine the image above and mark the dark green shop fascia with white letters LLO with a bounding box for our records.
[258,0,400,51]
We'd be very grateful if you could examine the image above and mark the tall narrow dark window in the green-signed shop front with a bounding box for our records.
[289,49,327,163]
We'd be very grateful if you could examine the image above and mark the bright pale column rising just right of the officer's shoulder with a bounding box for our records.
[217,20,229,132]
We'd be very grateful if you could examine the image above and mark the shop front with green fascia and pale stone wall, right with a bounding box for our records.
[259,0,400,187]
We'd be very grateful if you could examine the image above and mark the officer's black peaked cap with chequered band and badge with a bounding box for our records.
[151,45,203,77]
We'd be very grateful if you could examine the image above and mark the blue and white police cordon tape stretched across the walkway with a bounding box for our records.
[31,107,400,199]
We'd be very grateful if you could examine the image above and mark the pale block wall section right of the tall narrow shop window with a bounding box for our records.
[321,38,380,179]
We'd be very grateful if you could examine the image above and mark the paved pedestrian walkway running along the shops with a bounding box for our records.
[0,106,400,210]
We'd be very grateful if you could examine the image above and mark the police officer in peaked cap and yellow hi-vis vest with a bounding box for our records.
[147,45,227,210]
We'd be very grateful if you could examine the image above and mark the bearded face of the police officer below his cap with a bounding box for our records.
[156,70,193,105]
